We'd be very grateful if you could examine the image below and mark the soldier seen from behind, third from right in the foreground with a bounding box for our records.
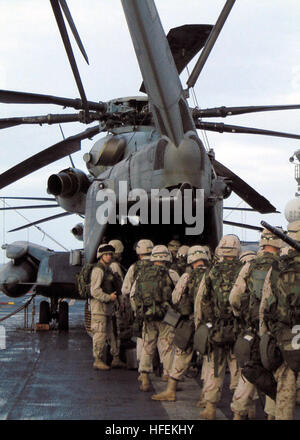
[198,235,241,419]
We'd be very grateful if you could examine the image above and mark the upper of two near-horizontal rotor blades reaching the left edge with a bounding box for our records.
[0,90,107,112]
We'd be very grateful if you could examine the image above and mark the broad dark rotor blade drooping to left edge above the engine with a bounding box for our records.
[0,126,100,189]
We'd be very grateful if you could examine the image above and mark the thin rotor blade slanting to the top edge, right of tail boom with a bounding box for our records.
[187,0,235,89]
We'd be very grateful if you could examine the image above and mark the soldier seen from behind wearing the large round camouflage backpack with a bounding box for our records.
[135,246,179,391]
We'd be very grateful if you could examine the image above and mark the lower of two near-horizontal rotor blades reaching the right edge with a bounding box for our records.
[195,121,300,139]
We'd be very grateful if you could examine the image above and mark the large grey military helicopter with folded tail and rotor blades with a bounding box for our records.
[0,0,300,328]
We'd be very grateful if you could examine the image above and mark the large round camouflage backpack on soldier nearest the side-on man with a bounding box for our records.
[135,264,174,321]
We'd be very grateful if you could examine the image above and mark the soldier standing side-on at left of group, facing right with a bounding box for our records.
[91,245,119,369]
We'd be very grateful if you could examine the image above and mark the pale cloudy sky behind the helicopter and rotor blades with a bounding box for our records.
[0,0,300,262]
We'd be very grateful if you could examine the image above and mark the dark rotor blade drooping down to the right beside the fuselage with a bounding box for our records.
[211,159,276,214]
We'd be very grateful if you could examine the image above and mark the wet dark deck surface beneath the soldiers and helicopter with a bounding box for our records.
[0,294,300,421]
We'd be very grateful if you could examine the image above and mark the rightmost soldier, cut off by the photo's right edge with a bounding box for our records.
[259,221,300,420]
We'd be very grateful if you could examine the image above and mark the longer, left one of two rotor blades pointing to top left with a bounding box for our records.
[50,0,89,118]
